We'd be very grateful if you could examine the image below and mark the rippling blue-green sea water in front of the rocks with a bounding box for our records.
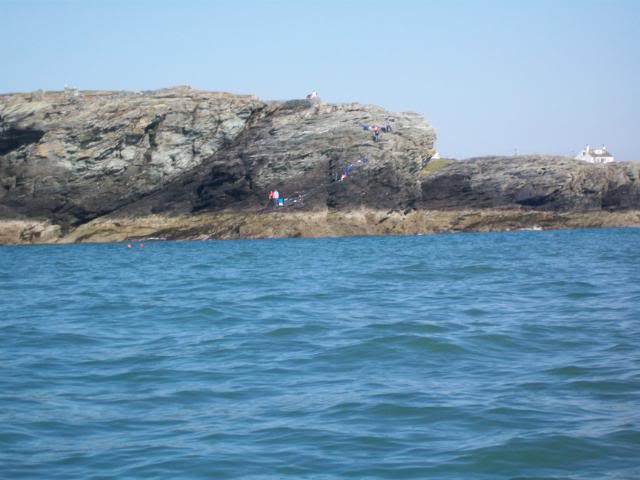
[0,229,640,479]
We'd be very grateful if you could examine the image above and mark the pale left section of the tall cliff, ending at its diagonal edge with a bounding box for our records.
[0,88,263,223]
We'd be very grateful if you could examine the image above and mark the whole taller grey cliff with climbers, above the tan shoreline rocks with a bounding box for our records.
[0,87,435,225]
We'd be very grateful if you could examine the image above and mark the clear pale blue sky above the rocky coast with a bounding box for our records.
[0,0,640,160]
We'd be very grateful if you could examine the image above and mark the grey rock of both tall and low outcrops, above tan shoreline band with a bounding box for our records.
[0,87,640,230]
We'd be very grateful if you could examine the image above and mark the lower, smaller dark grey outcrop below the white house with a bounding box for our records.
[420,155,640,211]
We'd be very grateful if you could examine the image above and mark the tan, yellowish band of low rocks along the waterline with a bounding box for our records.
[0,208,640,244]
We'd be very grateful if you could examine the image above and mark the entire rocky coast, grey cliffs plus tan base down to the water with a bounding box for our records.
[0,87,640,243]
